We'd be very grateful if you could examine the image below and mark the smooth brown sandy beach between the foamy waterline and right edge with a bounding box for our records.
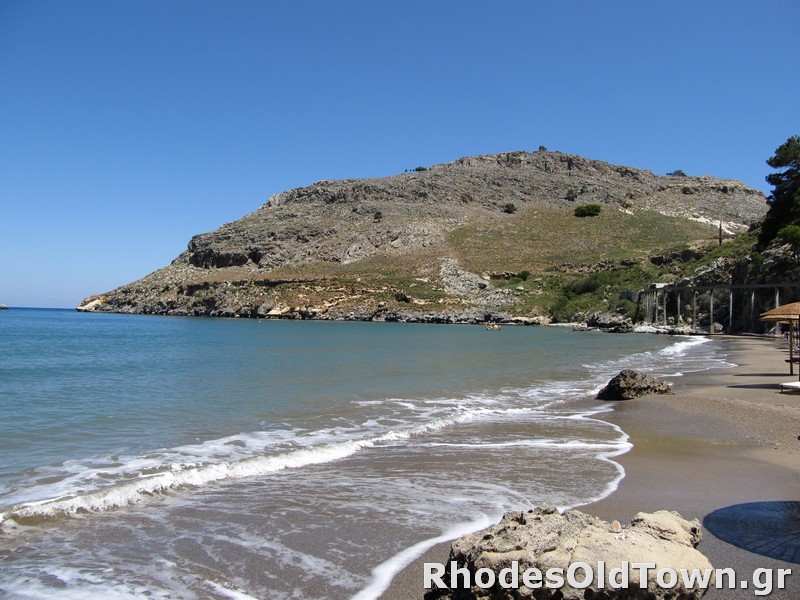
[381,337,800,600]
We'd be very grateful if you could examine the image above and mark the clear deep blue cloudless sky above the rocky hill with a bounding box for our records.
[0,0,800,307]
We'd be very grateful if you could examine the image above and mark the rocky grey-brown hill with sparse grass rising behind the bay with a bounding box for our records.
[79,149,767,321]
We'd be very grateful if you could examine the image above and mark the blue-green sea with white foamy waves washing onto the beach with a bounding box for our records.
[0,308,729,600]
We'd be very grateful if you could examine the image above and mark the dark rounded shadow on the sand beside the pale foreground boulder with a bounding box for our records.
[703,501,800,564]
